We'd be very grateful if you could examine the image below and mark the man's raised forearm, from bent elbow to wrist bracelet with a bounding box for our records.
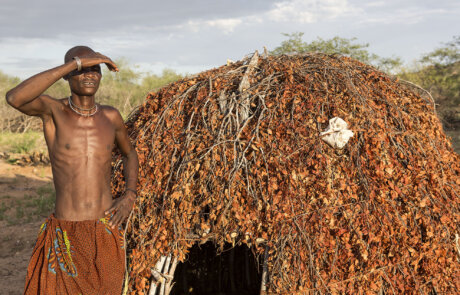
[6,61,77,108]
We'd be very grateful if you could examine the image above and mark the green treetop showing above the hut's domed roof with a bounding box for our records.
[271,32,402,71]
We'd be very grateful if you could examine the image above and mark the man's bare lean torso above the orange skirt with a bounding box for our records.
[43,99,115,220]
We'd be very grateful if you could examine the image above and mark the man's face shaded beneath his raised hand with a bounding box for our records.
[68,65,102,96]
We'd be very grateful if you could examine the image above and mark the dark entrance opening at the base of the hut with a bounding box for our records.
[171,242,262,295]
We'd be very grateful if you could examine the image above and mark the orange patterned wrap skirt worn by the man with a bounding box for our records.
[24,214,125,295]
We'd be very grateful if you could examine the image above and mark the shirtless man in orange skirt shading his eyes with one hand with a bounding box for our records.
[6,46,139,295]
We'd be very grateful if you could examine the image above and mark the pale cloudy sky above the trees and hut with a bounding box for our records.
[0,0,460,79]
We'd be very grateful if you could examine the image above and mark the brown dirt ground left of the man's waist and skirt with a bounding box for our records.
[0,160,54,295]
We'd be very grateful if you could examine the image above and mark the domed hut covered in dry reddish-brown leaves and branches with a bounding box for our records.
[113,53,460,294]
